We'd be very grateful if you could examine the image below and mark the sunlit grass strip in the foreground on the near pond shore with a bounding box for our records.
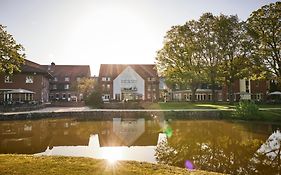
[0,154,223,175]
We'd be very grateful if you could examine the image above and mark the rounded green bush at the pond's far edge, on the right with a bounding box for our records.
[234,101,259,118]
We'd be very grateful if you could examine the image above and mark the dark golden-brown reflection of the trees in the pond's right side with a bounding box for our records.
[155,122,281,174]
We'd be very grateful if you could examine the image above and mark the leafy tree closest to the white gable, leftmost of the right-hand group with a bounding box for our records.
[156,21,206,101]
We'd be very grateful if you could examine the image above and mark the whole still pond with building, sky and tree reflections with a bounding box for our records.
[0,117,281,174]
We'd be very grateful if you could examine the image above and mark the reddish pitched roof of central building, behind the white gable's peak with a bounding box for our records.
[99,64,158,79]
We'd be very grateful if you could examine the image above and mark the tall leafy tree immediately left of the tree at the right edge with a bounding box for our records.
[214,14,251,103]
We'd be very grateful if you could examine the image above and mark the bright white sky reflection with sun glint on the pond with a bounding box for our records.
[36,133,167,163]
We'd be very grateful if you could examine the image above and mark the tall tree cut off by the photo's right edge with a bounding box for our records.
[247,2,281,85]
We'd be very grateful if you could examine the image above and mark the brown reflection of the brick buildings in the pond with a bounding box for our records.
[0,118,160,154]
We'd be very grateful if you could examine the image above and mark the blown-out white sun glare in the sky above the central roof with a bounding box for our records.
[64,6,158,74]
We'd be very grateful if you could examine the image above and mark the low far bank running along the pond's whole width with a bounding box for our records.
[0,107,281,122]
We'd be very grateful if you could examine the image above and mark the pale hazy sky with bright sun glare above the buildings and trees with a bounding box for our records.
[0,0,277,76]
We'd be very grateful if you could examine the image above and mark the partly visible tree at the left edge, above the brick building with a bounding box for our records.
[0,24,25,74]
